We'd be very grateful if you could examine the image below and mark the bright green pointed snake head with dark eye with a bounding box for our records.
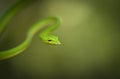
[40,35,60,45]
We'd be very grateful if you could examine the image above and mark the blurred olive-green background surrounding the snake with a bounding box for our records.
[0,0,120,79]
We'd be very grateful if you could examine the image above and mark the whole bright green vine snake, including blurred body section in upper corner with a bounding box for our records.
[0,0,61,60]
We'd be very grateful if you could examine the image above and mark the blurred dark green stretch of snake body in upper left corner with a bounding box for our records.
[0,0,32,34]
